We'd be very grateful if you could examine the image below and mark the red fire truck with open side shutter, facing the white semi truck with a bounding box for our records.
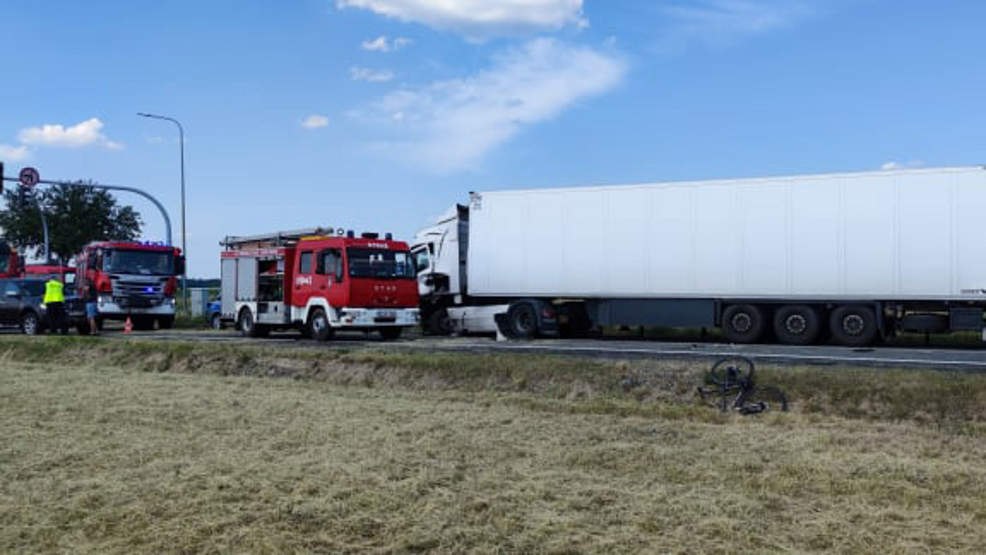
[220,228,419,341]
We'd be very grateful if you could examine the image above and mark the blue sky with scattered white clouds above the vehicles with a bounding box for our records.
[0,0,986,277]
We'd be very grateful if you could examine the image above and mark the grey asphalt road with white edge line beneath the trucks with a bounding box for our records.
[71,330,986,372]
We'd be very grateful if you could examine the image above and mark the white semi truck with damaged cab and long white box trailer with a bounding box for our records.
[412,166,986,346]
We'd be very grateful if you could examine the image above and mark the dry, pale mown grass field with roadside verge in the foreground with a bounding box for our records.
[0,338,986,553]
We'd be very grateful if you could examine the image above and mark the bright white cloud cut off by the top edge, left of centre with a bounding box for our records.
[336,0,588,39]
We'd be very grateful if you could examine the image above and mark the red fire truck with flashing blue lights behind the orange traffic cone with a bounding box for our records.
[76,241,185,330]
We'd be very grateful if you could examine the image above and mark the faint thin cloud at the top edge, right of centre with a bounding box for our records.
[659,0,814,50]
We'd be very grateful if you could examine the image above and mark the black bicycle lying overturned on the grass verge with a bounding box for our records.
[698,356,787,414]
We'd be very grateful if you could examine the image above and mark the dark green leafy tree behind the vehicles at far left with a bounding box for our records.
[0,181,144,262]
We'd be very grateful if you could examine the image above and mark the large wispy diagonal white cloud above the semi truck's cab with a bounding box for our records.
[358,39,626,173]
